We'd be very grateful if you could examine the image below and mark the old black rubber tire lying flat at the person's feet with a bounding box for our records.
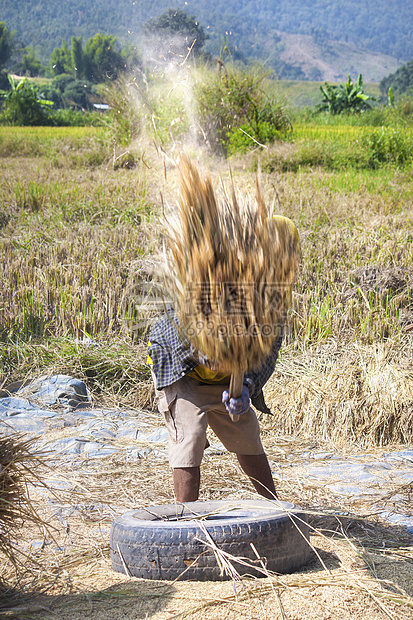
[110,500,312,581]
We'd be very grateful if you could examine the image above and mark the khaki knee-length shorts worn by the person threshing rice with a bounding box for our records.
[155,376,264,468]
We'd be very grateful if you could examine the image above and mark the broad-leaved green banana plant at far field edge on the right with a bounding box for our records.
[319,73,375,114]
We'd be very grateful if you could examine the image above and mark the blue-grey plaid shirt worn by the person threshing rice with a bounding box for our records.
[148,310,282,413]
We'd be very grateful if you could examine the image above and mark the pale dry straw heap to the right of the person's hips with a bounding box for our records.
[266,342,413,446]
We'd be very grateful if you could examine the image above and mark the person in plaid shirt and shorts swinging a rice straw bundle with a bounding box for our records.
[148,158,299,502]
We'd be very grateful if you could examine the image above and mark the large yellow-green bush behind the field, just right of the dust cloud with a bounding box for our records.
[195,68,291,154]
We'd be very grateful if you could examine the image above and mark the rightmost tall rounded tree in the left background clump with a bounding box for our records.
[84,33,125,83]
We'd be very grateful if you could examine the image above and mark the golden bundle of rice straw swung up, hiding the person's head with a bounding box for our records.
[166,156,299,396]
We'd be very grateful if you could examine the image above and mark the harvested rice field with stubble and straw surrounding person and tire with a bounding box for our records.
[0,109,413,620]
